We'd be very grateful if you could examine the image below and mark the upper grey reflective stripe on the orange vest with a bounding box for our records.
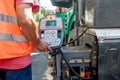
[0,14,18,24]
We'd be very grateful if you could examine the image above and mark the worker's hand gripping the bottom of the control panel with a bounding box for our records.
[36,39,52,52]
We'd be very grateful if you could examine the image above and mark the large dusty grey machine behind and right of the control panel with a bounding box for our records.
[45,0,120,80]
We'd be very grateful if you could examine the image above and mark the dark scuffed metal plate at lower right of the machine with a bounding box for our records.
[98,39,120,80]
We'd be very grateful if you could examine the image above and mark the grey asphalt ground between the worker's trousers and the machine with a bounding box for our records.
[32,51,53,80]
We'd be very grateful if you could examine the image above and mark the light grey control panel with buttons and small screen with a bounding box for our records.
[39,14,64,48]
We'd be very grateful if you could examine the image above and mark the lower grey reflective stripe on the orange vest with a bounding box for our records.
[0,33,28,42]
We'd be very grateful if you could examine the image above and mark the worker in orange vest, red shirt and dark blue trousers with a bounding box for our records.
[0,0,52,80]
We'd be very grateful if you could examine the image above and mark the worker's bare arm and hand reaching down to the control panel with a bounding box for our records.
[16,4,52,51]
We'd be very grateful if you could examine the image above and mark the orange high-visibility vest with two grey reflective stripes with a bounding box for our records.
[0,0,34,59]
